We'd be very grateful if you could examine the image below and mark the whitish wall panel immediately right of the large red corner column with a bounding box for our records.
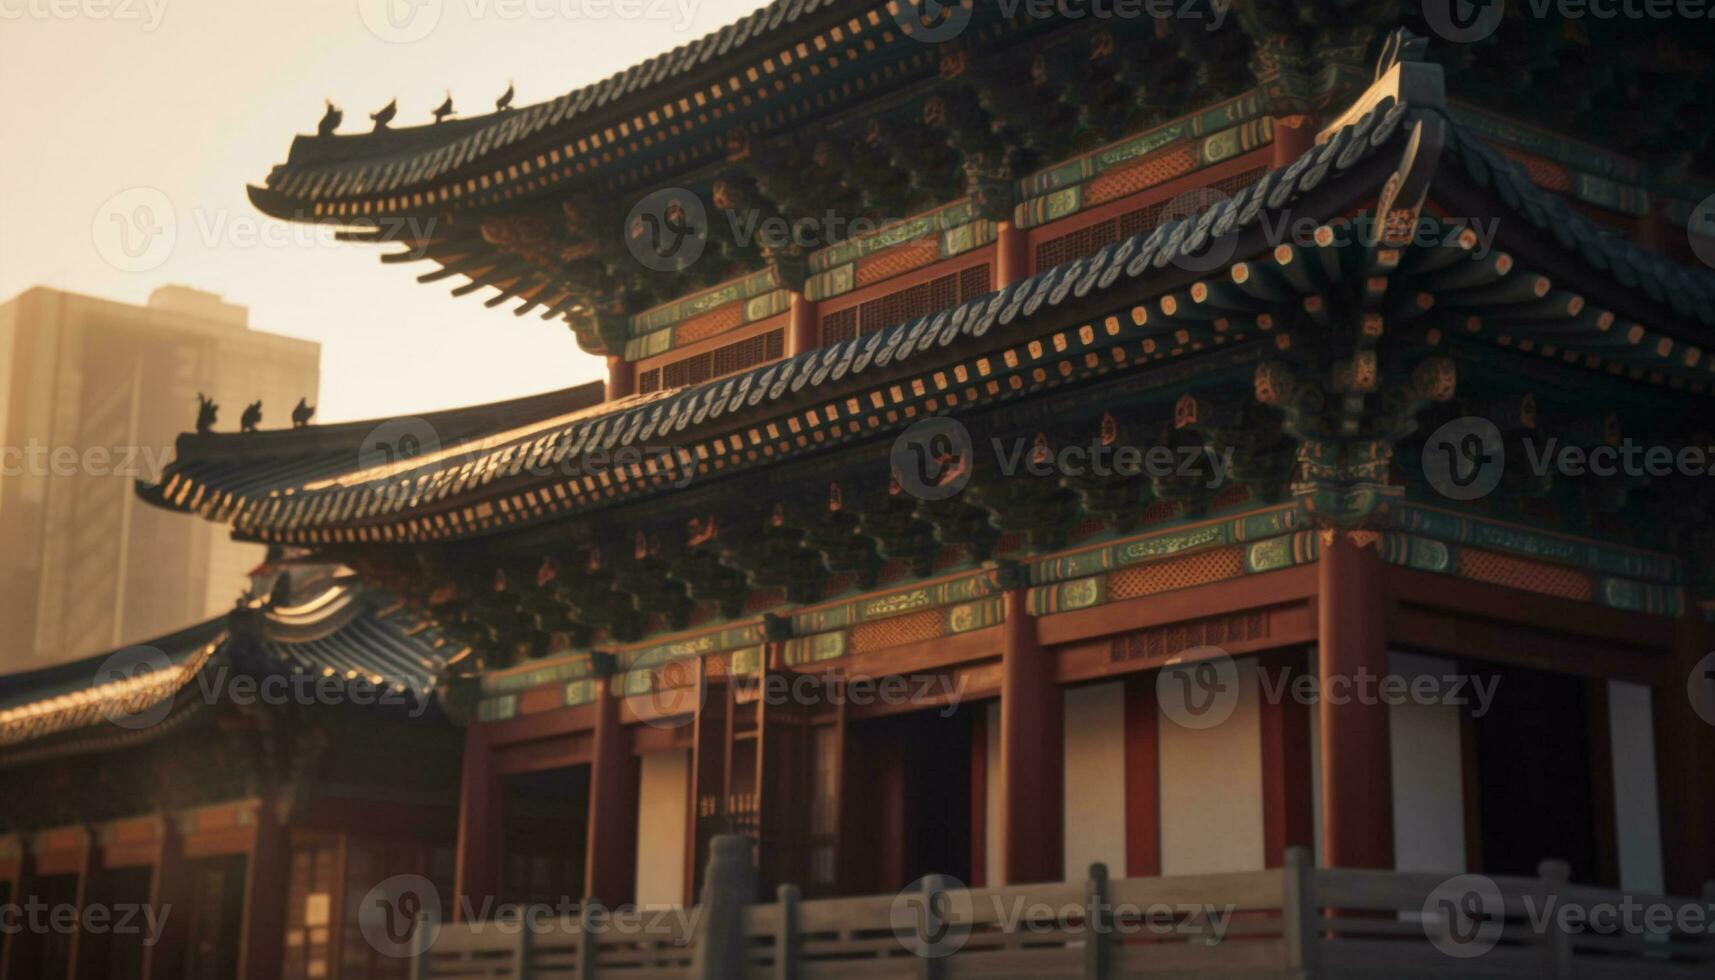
[1387,652,1468,874]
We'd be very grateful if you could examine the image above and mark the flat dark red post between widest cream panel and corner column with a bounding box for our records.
[1259,654,1315,868]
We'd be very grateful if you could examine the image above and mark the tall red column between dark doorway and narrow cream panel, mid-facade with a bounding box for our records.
[993,587,1065,884]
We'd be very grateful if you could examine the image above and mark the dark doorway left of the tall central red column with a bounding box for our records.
[845,709,976,894]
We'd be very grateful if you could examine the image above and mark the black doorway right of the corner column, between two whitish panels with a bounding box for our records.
[1473,668,1598,882]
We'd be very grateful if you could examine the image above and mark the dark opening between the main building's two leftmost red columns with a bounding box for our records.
[501,765,590,906]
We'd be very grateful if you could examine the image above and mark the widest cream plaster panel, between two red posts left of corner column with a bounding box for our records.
[1158,661,1262,875]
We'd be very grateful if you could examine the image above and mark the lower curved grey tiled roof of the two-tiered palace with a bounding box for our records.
[142,101,1715,544]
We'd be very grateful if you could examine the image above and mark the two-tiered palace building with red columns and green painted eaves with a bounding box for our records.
[3,0,1715,978]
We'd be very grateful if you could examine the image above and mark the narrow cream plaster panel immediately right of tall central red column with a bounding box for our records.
[1063,683,1125,880]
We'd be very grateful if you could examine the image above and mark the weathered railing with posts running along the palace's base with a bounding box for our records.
[412,844,1715,980]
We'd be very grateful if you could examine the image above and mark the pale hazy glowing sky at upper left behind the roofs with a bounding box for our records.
[0,0,763,422]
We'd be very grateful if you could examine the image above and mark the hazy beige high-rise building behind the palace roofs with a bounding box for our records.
[0,287,321,673]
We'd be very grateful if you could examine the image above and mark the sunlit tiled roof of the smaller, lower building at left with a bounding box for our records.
[0,580,454,745]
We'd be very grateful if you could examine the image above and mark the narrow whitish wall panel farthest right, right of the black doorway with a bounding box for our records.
[1609,681,1665,894]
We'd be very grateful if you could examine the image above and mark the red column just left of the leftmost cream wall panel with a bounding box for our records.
[583,678,640,908]
